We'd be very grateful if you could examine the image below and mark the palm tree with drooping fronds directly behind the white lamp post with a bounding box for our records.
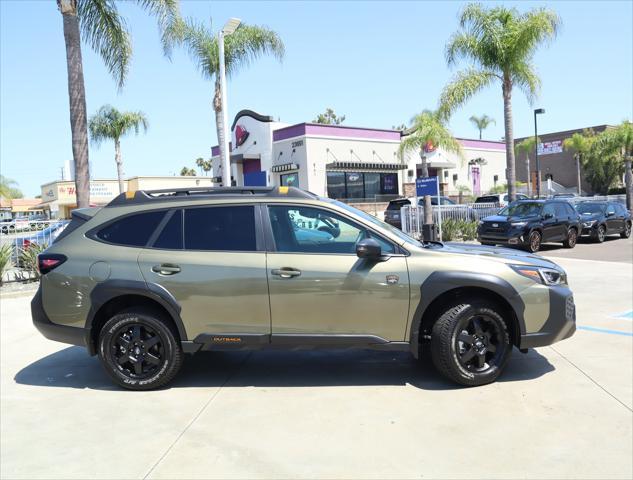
[167,19,285,181]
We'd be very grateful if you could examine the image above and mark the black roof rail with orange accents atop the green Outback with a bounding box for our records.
[106,187,317,207]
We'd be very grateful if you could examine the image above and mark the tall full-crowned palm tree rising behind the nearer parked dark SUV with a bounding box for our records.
[440,4,561,200]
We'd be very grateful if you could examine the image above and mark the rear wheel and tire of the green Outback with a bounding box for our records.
[99,309,183,390]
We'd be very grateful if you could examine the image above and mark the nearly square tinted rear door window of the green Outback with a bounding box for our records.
[184,205,257,252]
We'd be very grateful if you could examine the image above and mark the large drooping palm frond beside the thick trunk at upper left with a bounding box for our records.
[77,0,132,88]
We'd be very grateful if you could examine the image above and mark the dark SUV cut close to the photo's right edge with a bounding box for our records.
[576,200,631,243]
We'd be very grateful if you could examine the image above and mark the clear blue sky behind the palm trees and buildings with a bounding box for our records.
[0,0,633,196]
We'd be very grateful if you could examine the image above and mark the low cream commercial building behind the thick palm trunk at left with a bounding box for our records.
[38,176,213,218]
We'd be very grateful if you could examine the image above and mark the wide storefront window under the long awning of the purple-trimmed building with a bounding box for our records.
[327,172,398,199]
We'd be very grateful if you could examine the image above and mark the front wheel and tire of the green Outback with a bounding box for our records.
[431,299,512,387]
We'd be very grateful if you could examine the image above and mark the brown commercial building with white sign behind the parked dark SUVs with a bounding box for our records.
[514,125,612,194]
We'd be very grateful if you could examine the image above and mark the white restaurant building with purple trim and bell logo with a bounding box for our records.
[212,110,505,201]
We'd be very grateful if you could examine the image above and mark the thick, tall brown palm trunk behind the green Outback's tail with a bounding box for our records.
[62,5,90,208]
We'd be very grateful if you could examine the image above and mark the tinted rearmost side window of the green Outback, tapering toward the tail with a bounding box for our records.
[96,210,166,247]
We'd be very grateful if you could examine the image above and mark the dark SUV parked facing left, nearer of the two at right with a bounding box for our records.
[477,200,582,252]
